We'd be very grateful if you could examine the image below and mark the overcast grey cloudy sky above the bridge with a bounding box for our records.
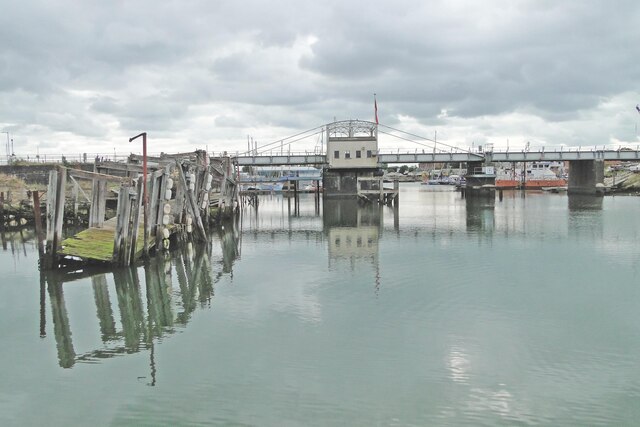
[0,0,640,157]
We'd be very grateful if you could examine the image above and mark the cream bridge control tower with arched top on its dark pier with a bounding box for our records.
[323,120,382,198]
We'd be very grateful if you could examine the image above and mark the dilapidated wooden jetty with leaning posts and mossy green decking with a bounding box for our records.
[40,150,238,269]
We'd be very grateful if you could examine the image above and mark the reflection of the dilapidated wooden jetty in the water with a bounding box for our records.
[40,224,239,374]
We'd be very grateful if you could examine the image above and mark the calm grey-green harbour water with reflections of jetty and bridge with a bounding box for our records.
[0,184,640,426]
